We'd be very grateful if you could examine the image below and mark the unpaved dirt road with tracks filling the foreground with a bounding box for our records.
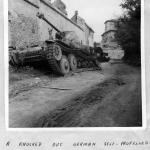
[9,64,142,127]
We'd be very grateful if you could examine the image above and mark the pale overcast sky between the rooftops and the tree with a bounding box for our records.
[52,0,123,42]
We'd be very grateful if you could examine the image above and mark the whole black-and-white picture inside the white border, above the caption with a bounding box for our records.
[6,0,145,129]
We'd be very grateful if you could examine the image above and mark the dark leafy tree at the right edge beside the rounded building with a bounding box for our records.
[116,0,141,62]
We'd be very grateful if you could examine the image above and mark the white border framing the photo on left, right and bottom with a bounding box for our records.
[3,0,147,132]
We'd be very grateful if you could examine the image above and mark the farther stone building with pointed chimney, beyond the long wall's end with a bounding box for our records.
[71,11,94,47]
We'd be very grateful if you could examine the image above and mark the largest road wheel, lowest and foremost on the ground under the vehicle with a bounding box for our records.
[60,55,70,75]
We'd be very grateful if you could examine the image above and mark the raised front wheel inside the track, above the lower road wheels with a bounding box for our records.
[53,45,62,61]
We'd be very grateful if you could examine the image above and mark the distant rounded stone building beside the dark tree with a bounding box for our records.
[101,19,124,59]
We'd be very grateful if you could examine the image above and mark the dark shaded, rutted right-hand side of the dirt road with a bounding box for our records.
[35,63,142,127]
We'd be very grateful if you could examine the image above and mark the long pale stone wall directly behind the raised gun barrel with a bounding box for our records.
[9,0,86,48]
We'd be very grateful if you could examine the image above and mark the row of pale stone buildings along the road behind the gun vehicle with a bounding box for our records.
[8,0,94,50]
